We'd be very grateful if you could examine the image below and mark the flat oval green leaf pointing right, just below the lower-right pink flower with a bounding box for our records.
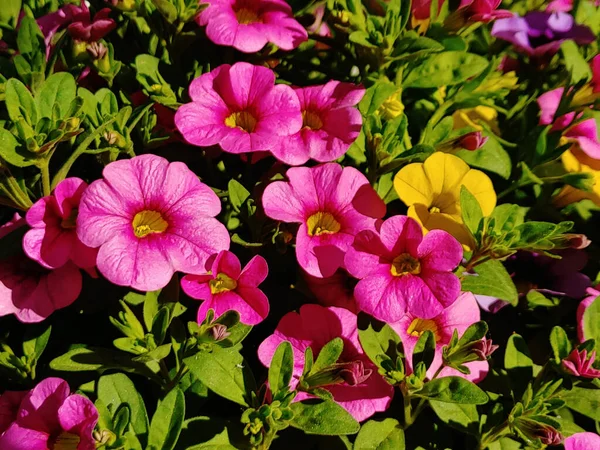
[414,377,488,405]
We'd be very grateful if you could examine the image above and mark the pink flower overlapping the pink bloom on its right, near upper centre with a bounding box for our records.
[175,62,302,153]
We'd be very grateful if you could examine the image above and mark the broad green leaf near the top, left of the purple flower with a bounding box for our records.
[403,51,489,88]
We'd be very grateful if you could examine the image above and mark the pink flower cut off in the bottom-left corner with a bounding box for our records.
[0,378,98,450]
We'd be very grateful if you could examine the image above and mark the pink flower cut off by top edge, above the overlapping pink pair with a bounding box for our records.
[196,0,308,53]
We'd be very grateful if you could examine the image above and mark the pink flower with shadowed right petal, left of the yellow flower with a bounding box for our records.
[262,163,385,278]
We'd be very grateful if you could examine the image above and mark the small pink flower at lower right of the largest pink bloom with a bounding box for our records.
[181,250,269,325]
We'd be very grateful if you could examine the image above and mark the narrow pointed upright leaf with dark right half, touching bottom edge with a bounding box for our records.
[148,388,185,450]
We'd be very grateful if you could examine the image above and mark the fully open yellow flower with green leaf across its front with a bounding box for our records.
[394,152,496,247]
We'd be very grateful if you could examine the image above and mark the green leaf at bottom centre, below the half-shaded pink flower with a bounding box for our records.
[290,399,360,436]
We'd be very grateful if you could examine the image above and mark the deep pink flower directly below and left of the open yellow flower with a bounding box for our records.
[345,216,463,321]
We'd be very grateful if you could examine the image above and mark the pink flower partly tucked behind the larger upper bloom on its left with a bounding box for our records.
[272,81,365,165]
